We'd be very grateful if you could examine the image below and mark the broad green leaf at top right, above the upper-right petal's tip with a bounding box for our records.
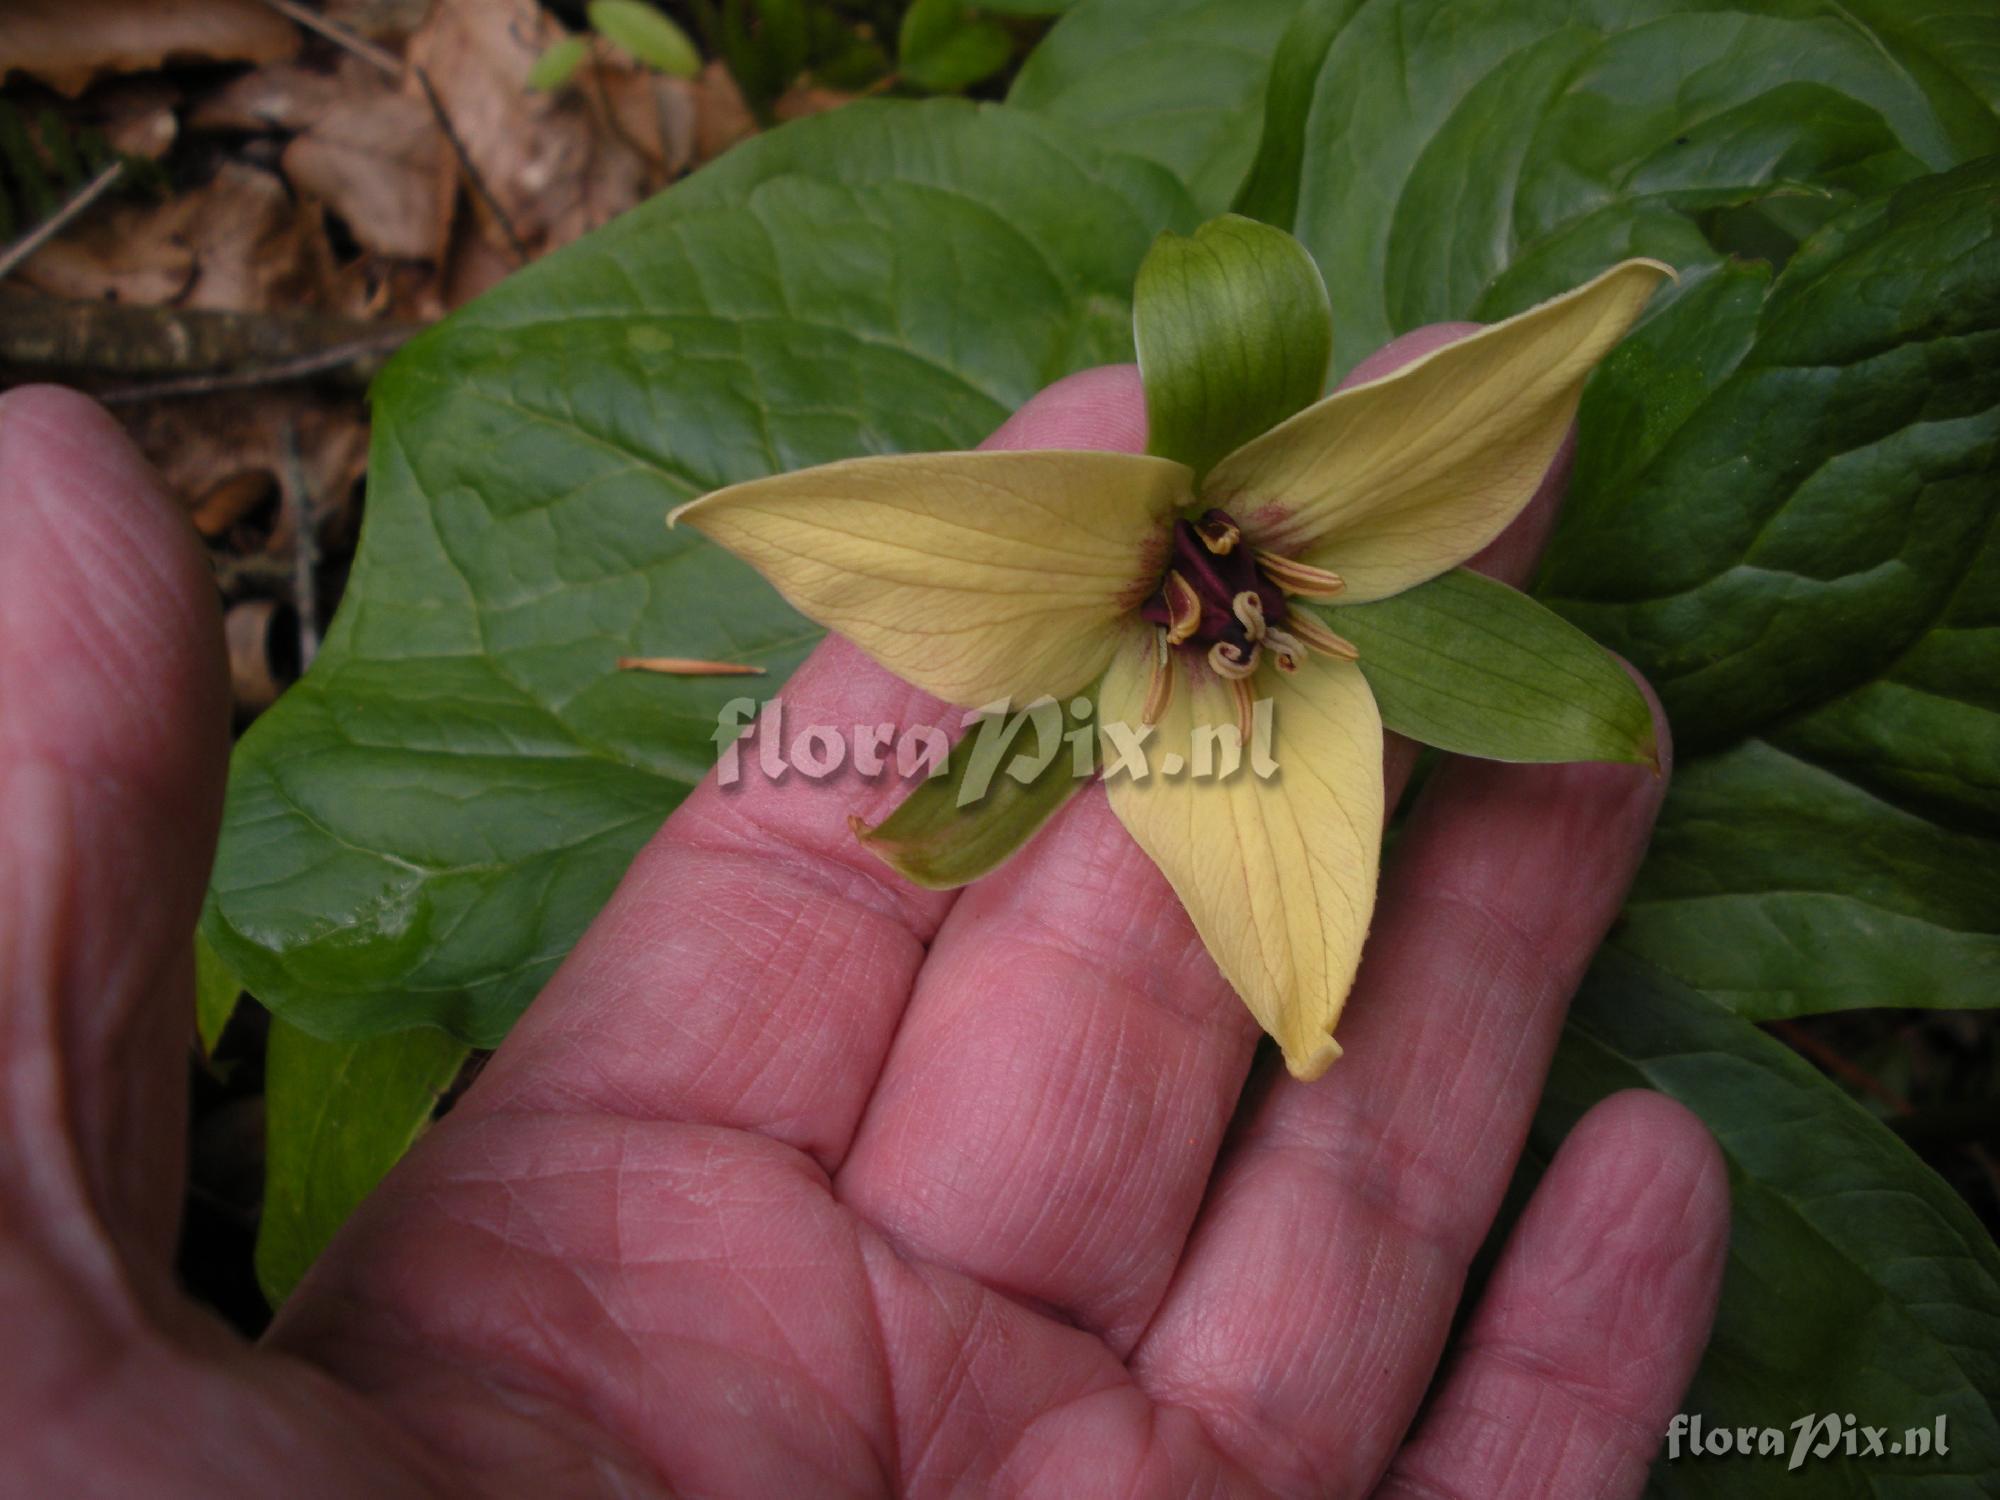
[1238,0,2000,370]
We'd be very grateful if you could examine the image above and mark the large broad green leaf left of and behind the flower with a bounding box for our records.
[204,102,1194,1044]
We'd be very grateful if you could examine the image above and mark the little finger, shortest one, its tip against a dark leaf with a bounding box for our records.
[1380,1090,1730,1500]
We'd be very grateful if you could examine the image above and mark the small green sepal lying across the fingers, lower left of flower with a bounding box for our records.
[854,696,1098,890]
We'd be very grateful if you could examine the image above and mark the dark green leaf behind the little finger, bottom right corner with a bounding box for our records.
[1530,958,2000,1500]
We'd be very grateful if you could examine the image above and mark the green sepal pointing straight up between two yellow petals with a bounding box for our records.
[1132,214,1334,480]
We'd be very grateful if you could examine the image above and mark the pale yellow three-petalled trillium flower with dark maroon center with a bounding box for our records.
[670,232,1672,1080]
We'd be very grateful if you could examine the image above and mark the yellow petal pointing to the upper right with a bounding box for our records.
[1202,260,1674,604]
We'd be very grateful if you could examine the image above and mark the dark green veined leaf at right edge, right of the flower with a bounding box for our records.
[1538,158,2000,750]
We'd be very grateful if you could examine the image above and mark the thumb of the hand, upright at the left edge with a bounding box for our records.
[0,386,228,1288]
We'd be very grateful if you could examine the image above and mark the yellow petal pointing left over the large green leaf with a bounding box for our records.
[668,450,1192,706]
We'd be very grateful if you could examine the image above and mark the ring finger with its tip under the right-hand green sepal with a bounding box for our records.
[1134,688,1664,1492]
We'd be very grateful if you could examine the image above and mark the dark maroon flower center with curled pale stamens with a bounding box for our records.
[1138,510,1358,724]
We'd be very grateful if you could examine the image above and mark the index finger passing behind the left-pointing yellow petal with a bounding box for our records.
[462,370,1130,1170]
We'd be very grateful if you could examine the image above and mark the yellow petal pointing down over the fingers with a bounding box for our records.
[1100,642,1382,1080]
